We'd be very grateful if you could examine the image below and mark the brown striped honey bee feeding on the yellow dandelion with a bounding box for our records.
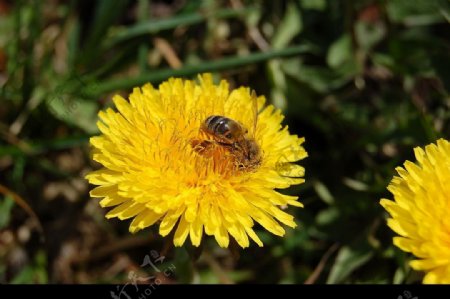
[201,91,262,170]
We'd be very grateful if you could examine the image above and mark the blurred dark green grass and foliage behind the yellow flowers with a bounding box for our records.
[0,0,450,283]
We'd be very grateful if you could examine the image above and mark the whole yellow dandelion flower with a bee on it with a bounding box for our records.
[86,74,307,248]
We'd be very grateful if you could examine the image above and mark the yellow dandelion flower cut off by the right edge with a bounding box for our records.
[380,139,450,284]
